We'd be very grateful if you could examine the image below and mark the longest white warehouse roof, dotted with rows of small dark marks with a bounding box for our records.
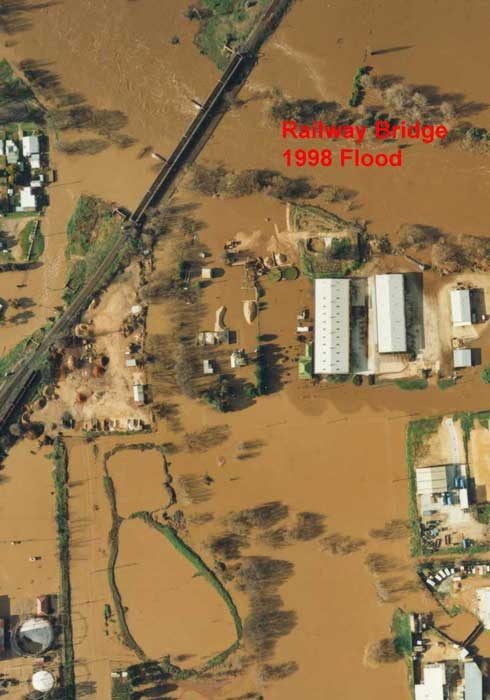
[314,278,350,374]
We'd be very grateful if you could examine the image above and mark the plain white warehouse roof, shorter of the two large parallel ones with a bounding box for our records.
[375,274,407,352]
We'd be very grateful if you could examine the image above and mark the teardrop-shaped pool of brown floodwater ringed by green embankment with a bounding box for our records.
[116,519,235,668]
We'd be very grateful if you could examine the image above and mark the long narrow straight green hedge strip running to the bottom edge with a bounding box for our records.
[51,438,75,700]
